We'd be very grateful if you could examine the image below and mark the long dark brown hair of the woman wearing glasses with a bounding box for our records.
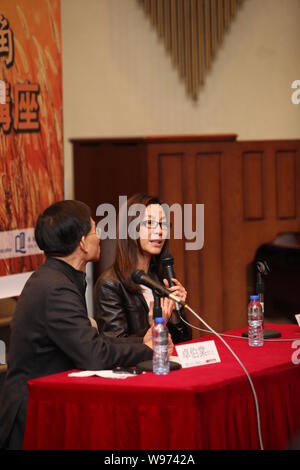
[112,194,168,293]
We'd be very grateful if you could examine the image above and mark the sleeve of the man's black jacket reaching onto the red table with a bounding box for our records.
[46,286,152,370]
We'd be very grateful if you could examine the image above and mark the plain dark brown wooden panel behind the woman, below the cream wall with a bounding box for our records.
[73,139,147,278]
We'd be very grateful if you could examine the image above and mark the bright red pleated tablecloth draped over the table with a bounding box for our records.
[24,325,300,450]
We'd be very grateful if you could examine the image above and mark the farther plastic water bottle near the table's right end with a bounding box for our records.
[248,295,264,346]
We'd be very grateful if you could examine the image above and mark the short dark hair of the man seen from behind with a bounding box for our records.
[35,200,91,256]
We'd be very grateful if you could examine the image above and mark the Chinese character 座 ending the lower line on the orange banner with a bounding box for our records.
[14,83,40,131]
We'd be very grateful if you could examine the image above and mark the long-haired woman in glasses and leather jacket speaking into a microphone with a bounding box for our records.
[94,194,191,343]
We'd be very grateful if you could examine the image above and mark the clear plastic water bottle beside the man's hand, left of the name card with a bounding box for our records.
[152,317,170,375]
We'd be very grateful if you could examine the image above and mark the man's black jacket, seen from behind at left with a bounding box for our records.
[0,258,152,447]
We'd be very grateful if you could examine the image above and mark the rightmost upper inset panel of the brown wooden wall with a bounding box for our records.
[276,151,299,219]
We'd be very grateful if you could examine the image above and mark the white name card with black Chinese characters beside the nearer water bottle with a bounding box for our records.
[175,341,221,368]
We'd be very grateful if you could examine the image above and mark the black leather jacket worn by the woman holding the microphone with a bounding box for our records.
[94,268,192,344]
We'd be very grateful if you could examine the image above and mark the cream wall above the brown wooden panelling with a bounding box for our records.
[61,0,300,197]
